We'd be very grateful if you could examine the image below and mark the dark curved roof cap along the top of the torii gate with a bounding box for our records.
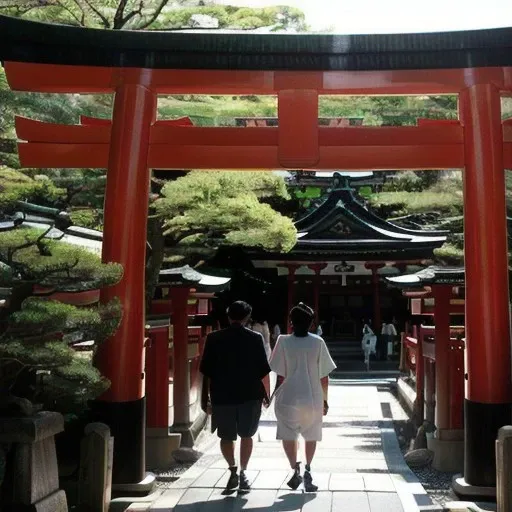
[0,16,512,71]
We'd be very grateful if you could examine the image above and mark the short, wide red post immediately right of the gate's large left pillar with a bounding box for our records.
[146,325,169,429]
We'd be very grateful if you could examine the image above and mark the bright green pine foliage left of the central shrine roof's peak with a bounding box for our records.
[154,171,296,264]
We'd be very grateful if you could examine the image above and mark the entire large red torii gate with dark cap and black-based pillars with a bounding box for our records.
[0,16,512,496]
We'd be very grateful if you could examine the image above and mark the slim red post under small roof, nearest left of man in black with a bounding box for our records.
[171,287,190,426]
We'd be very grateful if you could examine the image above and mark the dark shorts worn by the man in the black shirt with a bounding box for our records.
[212,400,261,441]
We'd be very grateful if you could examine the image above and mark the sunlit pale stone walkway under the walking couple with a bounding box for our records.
[150,382,431,512]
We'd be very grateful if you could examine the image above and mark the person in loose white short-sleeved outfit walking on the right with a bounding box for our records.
[270,303,336,492]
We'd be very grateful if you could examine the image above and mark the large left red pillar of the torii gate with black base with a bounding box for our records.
[94,83,156,484]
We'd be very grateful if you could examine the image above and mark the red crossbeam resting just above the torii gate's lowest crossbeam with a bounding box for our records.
[15,122,464,147]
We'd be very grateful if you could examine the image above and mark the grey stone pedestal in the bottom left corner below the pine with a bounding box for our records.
[0,412,68,512]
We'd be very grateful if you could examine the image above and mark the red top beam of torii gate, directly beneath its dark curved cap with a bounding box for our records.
[4,62,512,95]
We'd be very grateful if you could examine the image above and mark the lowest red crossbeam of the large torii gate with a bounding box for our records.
[18,143,472,170]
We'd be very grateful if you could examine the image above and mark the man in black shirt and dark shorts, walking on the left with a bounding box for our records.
[200,301,270,489]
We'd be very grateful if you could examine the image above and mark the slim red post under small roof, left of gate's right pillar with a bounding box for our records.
[432,285,452,430]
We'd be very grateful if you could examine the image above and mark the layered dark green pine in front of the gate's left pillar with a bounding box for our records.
[0,227,122,413]
